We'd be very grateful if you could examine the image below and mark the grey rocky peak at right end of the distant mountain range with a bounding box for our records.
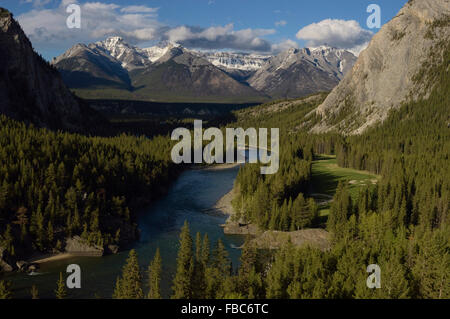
[248,47,356,98]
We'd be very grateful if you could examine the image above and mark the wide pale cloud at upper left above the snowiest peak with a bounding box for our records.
[18,0,162,49]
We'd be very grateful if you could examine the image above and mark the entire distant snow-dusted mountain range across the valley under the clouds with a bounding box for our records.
[52,37,356,103]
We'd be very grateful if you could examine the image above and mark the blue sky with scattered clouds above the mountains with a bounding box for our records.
[0,0,407,59]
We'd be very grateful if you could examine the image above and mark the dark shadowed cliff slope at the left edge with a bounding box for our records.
[0,8,97,131]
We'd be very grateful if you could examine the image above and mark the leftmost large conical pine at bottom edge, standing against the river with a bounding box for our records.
[113,249,144,299]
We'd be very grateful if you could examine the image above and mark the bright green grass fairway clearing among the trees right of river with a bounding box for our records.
[309,155,380,216]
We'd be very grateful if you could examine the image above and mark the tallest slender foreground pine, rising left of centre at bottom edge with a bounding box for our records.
[172,221,194,299]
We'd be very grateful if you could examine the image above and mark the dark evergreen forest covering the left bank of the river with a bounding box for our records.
[0,116,177,258]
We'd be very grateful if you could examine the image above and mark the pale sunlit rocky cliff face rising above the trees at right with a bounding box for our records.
[312,0,450,134]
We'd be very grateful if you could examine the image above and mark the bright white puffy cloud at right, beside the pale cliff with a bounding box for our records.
[297,19,373,54]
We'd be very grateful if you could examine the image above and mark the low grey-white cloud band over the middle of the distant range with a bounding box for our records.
[163,24,275,52]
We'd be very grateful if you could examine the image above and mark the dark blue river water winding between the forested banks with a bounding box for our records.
[6,167,244,298]
